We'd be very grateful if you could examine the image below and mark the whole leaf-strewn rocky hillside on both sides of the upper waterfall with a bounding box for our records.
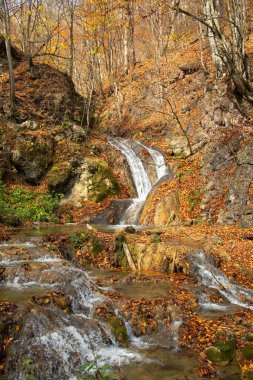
[0,37,253,226]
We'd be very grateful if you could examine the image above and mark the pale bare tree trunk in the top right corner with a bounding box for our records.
[170,0,253,103]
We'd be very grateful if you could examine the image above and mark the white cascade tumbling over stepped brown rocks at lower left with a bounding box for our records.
[0,236,145,380]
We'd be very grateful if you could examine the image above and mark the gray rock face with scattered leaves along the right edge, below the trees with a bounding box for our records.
[201,89,253,227]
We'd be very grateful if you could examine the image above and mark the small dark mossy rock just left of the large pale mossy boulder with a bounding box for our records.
[47,161,73,193]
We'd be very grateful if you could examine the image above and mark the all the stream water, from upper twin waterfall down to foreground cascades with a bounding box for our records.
[0,138,253,380]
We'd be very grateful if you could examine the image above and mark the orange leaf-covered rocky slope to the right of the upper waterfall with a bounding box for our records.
[99,36,253,226]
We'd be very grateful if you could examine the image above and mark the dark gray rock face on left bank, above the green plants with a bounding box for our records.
[11,134,54,185]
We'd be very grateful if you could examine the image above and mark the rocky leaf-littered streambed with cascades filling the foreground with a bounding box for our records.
[0,226,253,380]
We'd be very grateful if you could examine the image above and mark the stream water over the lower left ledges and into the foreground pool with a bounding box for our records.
[0,227,201,380]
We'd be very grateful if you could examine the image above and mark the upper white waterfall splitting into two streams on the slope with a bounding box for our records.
[108,138,170,225]
